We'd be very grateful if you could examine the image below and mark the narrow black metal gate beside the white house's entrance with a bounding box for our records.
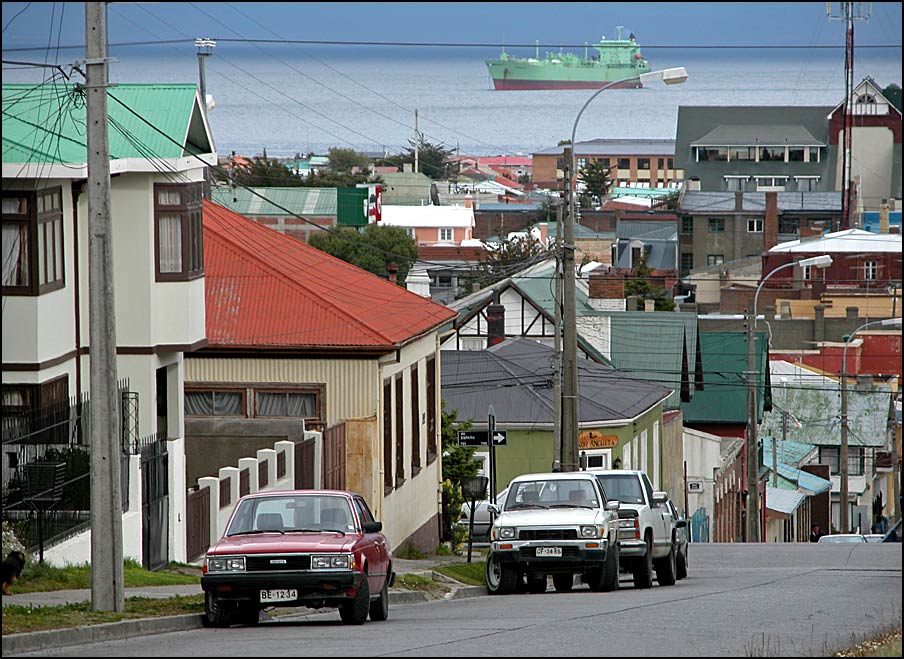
[141,437,169,570]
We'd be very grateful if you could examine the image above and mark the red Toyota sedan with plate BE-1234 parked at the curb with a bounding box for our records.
[201,490,395,627]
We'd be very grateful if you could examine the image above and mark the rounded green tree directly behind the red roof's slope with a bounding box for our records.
[308,224,417,286]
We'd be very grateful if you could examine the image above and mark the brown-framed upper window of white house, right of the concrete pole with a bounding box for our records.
[154,182,204,281]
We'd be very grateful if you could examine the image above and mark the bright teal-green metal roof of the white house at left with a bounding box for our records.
[2,84,214,165]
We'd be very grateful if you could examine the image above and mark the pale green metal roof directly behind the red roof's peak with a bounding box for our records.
[210,186,338,217]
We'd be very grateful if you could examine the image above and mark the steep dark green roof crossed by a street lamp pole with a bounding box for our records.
[681,332,769,424]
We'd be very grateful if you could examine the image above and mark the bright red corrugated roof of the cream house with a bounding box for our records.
[204,200,456,349]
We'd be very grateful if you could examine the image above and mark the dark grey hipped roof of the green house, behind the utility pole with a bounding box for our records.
[441,338,670,428]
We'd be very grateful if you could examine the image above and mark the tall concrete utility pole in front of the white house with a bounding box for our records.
[85,2,125,611]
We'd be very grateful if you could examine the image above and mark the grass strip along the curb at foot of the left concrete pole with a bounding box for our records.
[3,595,204,636]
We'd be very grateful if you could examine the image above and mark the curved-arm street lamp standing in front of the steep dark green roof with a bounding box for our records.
[747,254,832,542]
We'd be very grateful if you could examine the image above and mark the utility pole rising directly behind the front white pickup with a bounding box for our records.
[562,144,578,471]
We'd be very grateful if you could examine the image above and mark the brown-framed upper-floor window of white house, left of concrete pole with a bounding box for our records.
[3,188,65,295]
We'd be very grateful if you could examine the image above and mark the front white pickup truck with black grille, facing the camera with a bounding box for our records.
[486,471,619,595]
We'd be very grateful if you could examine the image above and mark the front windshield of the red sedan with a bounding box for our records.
[226,494,355,536]
